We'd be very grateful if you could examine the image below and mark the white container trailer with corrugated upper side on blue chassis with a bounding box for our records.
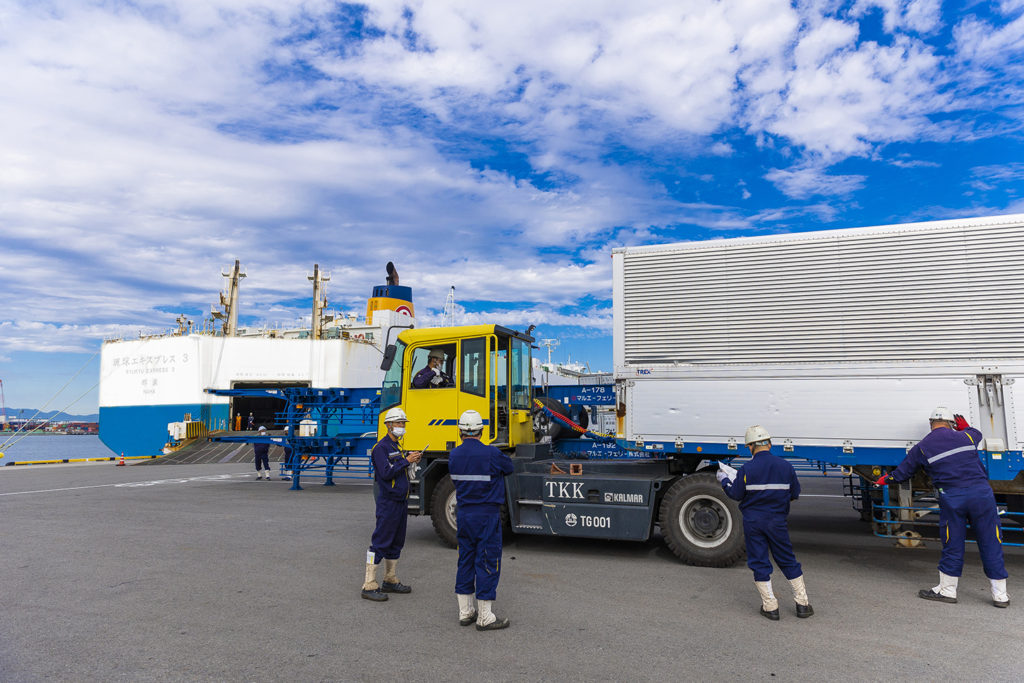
[612,214,1024,493]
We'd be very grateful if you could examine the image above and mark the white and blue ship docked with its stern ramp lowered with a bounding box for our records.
[99,261,416,457]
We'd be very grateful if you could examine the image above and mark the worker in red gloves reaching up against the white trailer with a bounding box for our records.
[874,407,1010,607]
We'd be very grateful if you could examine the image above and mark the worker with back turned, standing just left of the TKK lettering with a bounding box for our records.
[449,411,513,631]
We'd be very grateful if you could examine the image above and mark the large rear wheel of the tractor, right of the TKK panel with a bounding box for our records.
[658,474,743,567]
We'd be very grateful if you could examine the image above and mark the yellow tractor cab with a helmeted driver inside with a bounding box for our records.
[377,325,534,452]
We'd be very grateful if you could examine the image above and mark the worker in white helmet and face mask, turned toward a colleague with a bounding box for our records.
[361,408,422,602]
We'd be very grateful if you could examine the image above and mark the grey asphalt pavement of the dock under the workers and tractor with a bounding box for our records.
[0,463,1024,681]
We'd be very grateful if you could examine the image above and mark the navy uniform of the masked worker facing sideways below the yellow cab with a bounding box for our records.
[367,434,410,564]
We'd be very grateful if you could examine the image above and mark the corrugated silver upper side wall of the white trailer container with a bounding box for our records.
[613,214,1024,368]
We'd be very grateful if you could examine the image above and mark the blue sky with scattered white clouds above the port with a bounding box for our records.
[0,0,1024,413]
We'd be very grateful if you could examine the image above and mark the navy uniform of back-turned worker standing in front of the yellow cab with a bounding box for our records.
[449,438,513,600]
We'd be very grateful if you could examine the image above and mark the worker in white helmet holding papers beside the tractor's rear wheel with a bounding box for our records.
[718,425,814,622]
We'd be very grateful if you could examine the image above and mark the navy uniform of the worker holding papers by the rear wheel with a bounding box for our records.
[722,451,804,582]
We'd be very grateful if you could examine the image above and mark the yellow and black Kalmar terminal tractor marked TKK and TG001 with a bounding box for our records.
[378,325,743,566]
